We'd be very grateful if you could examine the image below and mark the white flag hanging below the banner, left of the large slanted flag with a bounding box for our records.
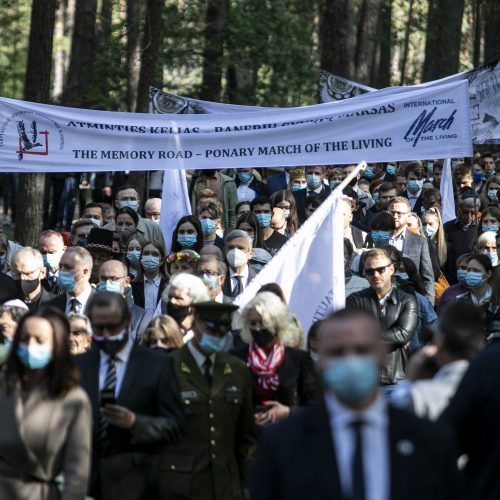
[160,170,191,251]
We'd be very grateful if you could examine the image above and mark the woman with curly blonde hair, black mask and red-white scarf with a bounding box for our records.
[232,292,317,426]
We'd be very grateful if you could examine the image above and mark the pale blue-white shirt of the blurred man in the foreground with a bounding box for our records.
[325,394,390,500]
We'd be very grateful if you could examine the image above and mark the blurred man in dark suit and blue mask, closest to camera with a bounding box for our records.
[251,310,461,500]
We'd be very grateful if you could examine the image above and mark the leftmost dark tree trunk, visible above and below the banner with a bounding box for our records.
[14,0,57,246]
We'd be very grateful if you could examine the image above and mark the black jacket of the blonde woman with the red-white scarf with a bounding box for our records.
[232,345,318,408]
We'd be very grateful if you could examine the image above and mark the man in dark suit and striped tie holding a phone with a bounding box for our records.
[75,292,187,500]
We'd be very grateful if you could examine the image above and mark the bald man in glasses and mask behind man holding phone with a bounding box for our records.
[97,260,152,343]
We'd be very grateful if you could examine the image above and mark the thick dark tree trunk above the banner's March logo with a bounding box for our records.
[423,0,464,82]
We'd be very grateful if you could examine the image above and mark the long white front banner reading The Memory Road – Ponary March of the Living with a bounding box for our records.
[0,78,472,172]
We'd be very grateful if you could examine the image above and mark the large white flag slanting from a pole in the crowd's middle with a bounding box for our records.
[235,190,345,332]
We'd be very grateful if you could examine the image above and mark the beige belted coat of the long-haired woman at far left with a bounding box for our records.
[0,378,92,500]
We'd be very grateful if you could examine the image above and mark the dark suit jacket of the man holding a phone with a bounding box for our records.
[75,345,183,500]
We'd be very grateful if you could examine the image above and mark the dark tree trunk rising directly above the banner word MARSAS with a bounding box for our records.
[354,0,382,85]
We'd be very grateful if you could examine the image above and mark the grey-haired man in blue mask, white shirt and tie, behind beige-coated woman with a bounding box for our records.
[45,247,95,315]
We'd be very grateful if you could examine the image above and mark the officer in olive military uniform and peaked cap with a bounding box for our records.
[160,301,256,500]
